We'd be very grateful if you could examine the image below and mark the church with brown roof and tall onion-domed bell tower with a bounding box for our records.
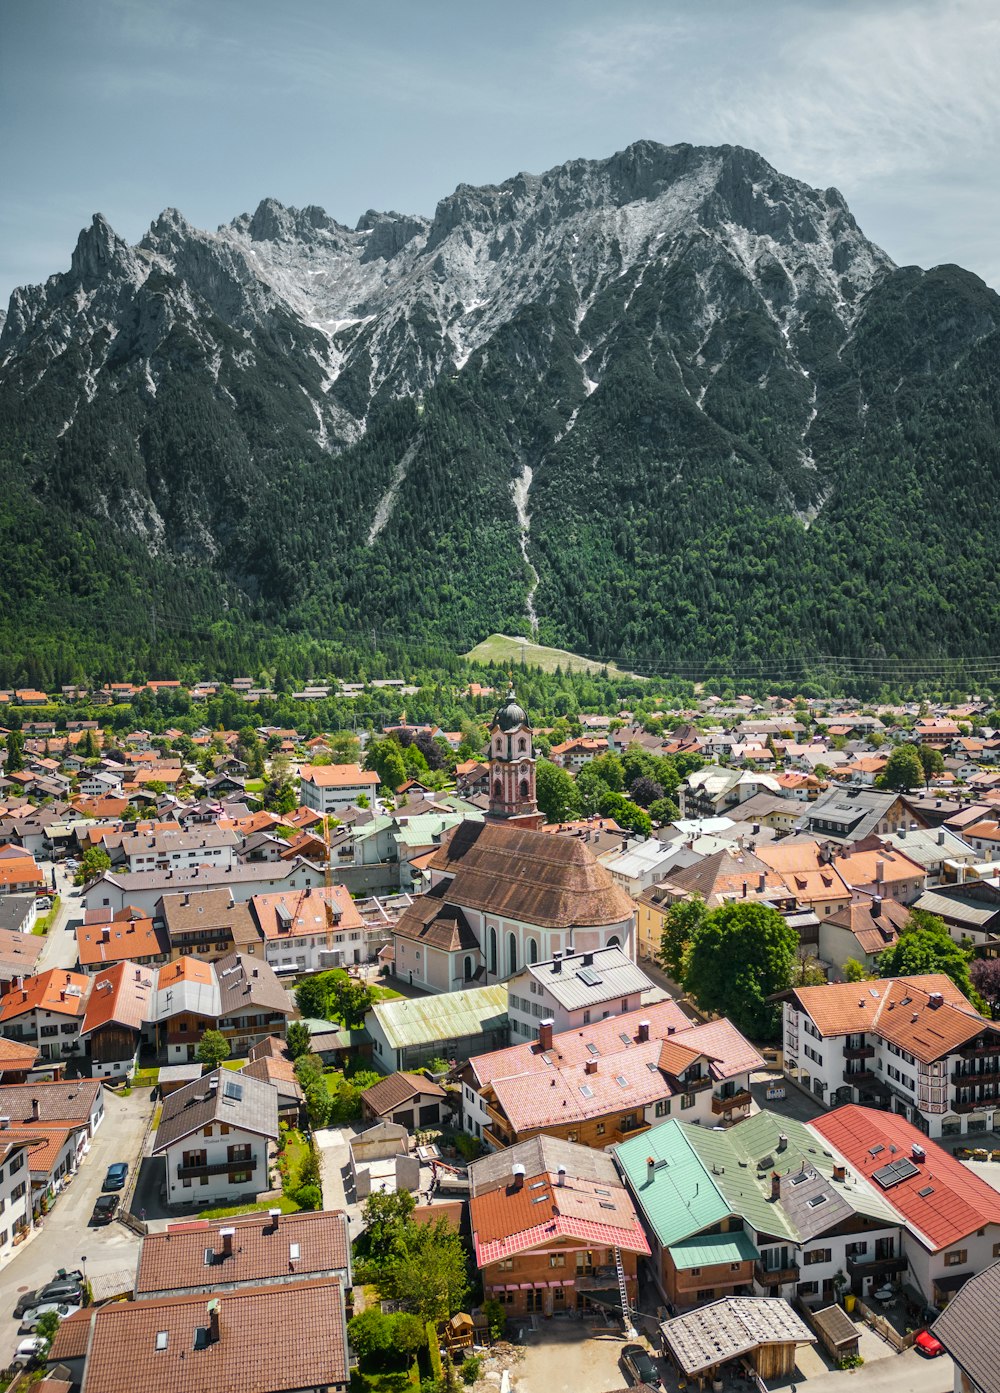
[393,688,635,992]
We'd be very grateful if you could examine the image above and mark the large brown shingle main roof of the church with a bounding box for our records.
[415,822,635,929]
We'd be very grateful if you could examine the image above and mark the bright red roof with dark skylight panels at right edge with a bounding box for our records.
[809,1103,1000,1252]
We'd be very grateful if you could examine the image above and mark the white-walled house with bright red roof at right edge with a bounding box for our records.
[809,1106,1000,1307]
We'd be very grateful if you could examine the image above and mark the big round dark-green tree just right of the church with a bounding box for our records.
[684,901,798,1039]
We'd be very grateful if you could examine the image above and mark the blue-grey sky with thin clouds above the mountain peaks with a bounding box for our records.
[0,0,1000,305]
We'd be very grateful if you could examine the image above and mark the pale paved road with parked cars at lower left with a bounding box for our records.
[0,1089,150,1364]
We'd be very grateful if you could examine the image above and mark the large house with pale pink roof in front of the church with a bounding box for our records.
[462,1000,762,1149]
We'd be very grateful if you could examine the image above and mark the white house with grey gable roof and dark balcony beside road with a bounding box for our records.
[152,1068,277,1205]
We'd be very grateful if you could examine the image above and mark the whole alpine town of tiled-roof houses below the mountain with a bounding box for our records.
[0,666,1000,1393]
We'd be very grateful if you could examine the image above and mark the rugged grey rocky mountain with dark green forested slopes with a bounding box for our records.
[0,141,1000,680]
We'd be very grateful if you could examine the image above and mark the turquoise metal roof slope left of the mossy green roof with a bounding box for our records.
[614,1117,731,1247]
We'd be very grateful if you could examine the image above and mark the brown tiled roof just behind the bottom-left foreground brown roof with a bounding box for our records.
[135,1209,352,1301]
